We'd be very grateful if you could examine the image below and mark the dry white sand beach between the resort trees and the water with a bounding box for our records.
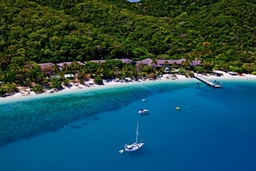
[0,71,256,102]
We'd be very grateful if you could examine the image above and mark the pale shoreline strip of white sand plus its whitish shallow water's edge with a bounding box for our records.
[0,71,256,104]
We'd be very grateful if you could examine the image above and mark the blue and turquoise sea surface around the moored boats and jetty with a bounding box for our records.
[0,79,256,171]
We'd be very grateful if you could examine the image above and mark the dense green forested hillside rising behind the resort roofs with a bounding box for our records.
[0,0,256,73]
